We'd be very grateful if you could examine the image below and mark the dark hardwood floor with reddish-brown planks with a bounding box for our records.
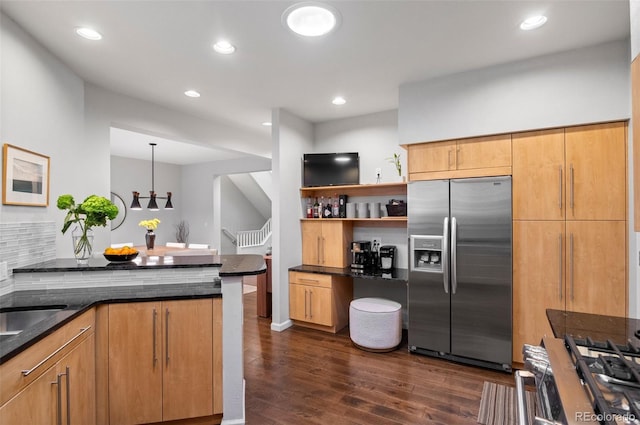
[244,292,514,425]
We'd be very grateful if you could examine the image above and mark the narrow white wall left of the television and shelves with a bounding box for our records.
[271,109,313,331]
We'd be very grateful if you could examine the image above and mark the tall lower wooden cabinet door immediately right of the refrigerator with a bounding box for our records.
[513,221,565,362]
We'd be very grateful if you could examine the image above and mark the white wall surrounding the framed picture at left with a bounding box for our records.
[0,14,110,258]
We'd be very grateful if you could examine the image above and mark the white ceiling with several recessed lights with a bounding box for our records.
[0,0,629,163]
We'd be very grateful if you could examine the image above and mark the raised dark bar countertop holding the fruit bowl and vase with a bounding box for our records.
[13,254,266,277]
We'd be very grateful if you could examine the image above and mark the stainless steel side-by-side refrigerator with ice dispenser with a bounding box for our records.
[407,176,512,371]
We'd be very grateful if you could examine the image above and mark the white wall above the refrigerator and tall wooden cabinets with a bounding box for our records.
[398,40,630,144]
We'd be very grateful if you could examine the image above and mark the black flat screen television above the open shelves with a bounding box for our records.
[302,152,360,187]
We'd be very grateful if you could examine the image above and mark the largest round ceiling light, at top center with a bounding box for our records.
[282,1,340,37]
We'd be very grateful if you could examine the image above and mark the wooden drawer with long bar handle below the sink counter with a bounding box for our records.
[0,308,95,406]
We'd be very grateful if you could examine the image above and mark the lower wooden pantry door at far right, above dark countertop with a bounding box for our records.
[566,221,627,316]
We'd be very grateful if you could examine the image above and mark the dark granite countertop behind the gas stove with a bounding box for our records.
[547,309,640,346]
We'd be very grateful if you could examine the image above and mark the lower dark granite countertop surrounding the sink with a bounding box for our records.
[0,282,222,364]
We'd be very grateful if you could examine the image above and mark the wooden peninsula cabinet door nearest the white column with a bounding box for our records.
[162,299,213,421]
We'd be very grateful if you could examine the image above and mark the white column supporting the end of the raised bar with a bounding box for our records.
[222,276,245,425]
